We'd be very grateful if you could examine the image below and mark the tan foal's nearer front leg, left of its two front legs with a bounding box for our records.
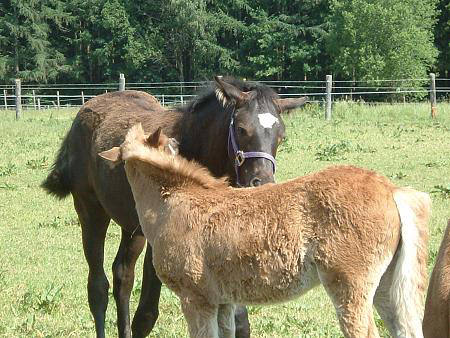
[181,299,219,338]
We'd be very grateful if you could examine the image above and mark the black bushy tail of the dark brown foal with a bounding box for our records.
[41,131,71,199]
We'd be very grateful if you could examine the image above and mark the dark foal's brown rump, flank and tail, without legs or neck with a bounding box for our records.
[43,91,178,228]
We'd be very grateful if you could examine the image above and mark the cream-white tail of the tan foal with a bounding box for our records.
[390,188,431,337]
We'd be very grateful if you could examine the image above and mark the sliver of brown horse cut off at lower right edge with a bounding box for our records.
[423,220,450,338]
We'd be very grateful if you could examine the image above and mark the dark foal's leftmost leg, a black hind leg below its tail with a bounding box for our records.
[73,193,110,338]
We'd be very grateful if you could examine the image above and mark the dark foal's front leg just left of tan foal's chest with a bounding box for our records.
[132,243,161,338]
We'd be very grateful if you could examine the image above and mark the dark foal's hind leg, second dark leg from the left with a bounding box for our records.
[113,229,145,338]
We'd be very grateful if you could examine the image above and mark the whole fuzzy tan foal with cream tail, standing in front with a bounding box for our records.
[101,125,431,337]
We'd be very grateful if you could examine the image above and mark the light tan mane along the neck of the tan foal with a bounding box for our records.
[121,124,228,189]
